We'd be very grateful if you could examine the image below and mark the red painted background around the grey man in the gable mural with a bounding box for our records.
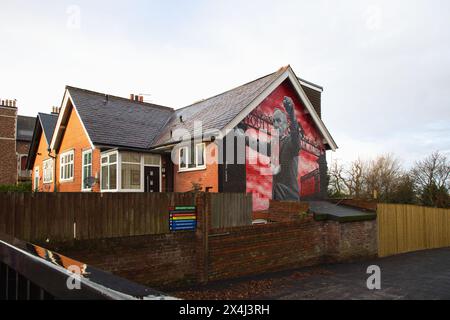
[244,80,325,211]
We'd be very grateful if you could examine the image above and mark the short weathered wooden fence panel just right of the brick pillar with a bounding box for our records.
[210,193,253,229]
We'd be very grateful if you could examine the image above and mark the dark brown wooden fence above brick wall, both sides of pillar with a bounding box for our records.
[0,192,252,242]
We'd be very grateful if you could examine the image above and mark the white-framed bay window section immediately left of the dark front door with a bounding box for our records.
[120,152,141,190]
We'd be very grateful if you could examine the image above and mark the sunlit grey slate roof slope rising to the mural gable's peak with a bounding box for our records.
[153,68,286,146]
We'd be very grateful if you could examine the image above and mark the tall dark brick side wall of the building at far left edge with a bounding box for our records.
[0,106,17,185]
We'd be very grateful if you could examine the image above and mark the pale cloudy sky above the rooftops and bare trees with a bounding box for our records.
[0,0,450,167]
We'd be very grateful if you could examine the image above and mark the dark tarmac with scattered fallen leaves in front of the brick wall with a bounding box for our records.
[171,248,450,300]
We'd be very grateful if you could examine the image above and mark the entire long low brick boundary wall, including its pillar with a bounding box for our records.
[51,211,377,289]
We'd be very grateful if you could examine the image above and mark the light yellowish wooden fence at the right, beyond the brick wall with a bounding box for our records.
[377,204,450,257]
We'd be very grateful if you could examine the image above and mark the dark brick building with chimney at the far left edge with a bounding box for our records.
[0,100,36,185]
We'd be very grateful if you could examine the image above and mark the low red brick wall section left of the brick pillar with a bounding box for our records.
[50,232,197,288]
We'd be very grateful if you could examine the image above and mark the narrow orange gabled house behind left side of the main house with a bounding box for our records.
[27,108,58,192]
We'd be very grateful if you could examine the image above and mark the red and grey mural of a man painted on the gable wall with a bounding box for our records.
[238,82,326,211]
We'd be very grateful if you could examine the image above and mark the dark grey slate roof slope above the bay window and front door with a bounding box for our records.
[66,86,174,149]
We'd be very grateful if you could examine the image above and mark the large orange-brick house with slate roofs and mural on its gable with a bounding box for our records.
[29,66,337,210]
